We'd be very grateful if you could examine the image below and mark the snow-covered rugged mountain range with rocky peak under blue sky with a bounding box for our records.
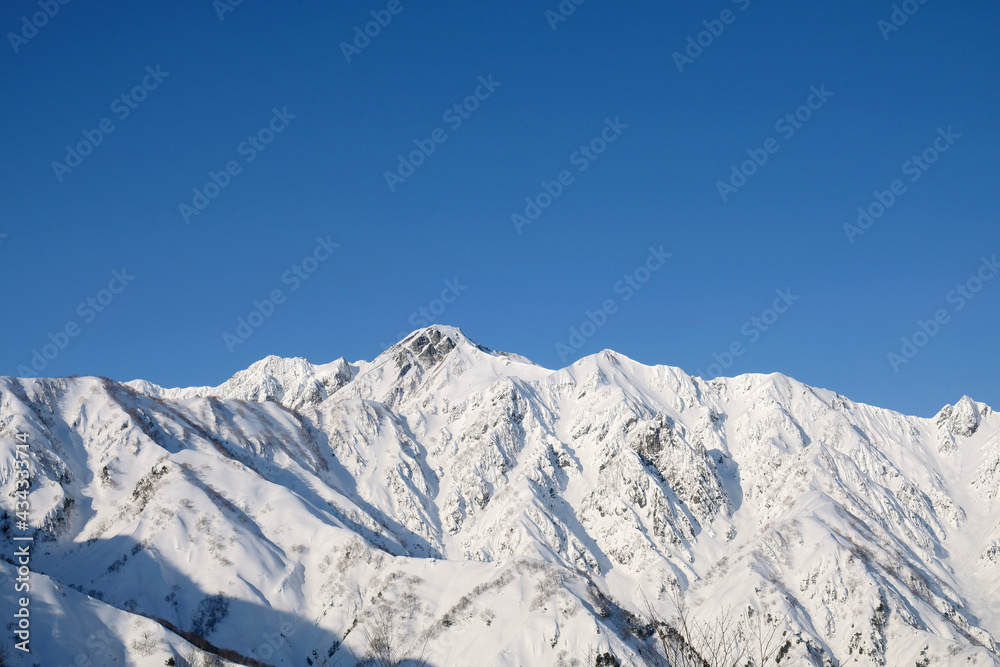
[0,326,1000,667]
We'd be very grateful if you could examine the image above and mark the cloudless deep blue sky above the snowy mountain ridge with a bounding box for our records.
[0,0,1000,415]
